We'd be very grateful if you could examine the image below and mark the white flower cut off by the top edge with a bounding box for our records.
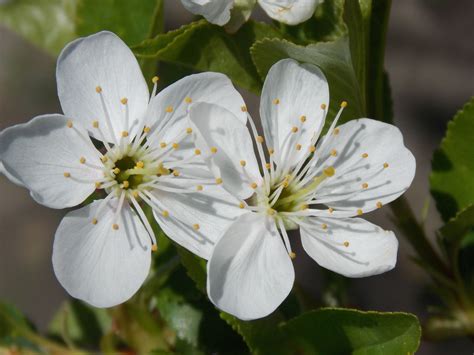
[181,0,322,26]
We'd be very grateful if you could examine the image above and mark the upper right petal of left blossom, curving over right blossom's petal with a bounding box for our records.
[146,72,247,150]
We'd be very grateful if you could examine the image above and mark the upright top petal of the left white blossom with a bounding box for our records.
[56,31,149,142]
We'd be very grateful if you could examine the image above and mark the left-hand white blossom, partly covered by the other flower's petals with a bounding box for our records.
[0,32,246,307]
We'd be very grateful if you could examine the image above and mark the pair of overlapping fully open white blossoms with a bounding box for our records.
[0,31,415,319]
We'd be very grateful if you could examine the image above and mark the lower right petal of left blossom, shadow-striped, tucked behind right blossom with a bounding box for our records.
[153,185,244,259]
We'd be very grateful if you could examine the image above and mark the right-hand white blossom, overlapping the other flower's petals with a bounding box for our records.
[190,59,415,320]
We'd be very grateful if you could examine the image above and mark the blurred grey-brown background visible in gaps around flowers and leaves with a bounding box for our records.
[0,0,474,354]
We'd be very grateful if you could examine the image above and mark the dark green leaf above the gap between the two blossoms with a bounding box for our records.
[132,20,281,92]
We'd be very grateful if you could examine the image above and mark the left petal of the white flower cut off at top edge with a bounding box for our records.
[181,0,234,26]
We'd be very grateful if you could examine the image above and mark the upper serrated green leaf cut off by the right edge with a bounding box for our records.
[430,98,474,221]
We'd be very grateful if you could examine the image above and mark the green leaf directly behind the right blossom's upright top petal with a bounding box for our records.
[251,37,365,127]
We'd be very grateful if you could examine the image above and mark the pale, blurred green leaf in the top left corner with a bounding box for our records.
[0,0,76,55]
